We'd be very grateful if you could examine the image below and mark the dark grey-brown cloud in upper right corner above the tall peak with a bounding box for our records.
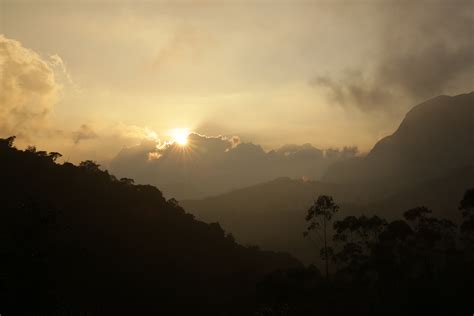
[311,0,474,112]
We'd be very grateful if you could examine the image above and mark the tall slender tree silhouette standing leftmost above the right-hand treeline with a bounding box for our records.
[303,195,339,279]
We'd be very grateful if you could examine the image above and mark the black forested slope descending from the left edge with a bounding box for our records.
[0,139,300,315]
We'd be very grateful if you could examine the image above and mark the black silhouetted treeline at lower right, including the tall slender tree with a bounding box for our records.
[258,193,474,315]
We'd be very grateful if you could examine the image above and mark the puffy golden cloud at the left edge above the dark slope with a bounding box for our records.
[0,35,61,138]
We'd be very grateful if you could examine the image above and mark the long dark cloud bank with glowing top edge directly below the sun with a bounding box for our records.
[110,133,357,198]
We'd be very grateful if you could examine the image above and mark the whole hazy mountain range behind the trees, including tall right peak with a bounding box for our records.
[180,92,474,262]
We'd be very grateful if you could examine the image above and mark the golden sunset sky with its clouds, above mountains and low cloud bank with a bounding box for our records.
[0,0,474,162]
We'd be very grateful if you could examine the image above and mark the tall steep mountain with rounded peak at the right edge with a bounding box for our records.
[323,92,474,190]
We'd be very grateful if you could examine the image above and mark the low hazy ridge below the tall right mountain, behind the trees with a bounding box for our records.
[181,167,474,263]
